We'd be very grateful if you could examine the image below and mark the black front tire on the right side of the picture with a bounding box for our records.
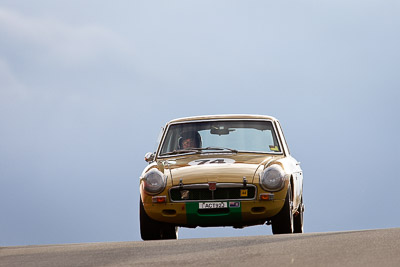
[272,183,294,235]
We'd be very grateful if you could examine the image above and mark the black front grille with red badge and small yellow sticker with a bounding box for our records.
[170,184,256,201]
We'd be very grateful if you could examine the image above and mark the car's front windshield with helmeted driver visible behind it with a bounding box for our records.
[159,120,281,156]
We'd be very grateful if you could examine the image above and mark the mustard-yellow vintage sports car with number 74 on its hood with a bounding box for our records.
[140,115,304,240]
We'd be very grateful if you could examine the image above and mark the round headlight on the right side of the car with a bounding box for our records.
[260,164,285,191]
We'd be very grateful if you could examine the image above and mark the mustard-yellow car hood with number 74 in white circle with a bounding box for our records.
[159,154,279,185]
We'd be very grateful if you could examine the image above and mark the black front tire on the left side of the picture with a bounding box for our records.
[139,198,178,240]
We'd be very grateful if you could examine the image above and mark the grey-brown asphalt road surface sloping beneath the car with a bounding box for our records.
[0,228,400,267]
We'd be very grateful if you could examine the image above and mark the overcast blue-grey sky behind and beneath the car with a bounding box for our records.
[0,0,400,246]
